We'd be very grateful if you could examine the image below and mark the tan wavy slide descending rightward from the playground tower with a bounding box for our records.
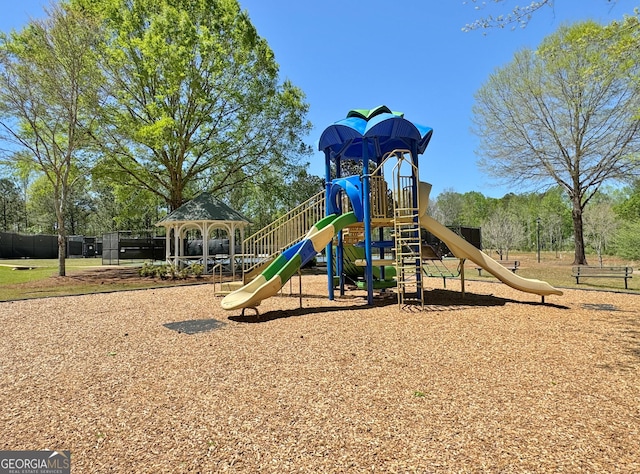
[419,182,562,296]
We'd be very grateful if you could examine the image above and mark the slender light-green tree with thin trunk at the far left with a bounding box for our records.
[0,5,102,276]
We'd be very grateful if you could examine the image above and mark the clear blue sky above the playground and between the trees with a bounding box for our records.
[0,0,640,197]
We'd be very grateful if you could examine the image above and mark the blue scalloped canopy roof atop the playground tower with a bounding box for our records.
[318,106,433,160]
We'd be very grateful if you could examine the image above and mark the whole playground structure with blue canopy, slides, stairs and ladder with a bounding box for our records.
[221,106,562,310]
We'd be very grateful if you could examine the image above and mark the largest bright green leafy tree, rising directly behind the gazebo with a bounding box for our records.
[70,0,310,211]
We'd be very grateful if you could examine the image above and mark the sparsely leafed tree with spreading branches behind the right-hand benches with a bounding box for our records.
[473,17,640,264]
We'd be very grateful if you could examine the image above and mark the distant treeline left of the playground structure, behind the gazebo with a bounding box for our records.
[0,167,324,236]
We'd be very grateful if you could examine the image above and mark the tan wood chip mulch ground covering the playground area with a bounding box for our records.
[0,276,640,473]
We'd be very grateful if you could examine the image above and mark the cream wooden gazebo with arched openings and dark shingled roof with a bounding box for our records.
[156,193,250,276]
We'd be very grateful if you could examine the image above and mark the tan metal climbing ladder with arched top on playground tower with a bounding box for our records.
[392,150,424,309]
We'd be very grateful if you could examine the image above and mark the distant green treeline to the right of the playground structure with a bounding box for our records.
[429,181,640,264]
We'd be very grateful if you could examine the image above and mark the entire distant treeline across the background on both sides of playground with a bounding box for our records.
[5,169,640,264]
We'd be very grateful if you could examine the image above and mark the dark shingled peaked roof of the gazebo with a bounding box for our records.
[156,193,249,226]
